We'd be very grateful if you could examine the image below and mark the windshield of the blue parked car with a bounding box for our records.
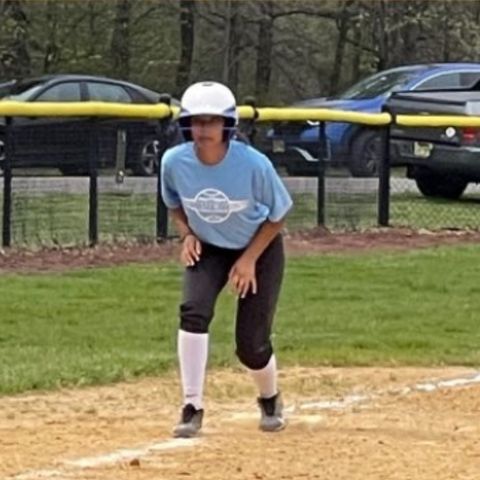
[335,69,426,100]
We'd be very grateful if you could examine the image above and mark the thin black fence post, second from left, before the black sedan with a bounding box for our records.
[88,118,98,247]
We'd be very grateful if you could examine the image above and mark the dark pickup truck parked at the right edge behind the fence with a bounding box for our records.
[387,85,480,199]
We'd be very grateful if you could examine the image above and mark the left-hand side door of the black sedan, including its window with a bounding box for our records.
[14,81,88,170]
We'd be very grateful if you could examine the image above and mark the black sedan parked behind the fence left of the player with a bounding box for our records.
[0,75,179,175]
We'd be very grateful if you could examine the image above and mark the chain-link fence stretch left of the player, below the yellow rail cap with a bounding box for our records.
[0,108,171,248]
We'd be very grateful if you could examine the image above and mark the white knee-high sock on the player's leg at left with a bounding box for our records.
[177,330,208,409]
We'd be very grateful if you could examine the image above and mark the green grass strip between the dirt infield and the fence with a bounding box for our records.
[0,246,480,394]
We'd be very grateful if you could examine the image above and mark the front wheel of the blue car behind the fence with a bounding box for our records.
[349,130,382,177]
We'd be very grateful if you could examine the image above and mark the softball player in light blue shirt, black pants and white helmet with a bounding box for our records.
[161,82,292,437]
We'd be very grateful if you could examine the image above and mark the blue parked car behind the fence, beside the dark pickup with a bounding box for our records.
[265,63,480,177]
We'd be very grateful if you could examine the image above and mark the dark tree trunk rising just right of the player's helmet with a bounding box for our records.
[255,0,273,105]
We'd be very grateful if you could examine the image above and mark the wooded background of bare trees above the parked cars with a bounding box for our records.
[0,0,480,105]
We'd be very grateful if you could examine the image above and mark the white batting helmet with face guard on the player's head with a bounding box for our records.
[178,82,238,142]
